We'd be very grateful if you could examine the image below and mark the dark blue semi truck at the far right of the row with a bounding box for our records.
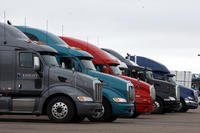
[130,56,198,112]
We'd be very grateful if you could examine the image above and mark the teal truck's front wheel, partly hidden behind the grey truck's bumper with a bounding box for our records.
[88,99,117,122]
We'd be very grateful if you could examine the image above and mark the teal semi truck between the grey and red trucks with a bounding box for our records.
[17,26,134,122]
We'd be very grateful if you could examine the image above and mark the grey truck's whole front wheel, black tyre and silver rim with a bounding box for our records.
[47,96,75,122]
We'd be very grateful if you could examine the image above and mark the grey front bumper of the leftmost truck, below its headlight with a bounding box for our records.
[76,102,102,116]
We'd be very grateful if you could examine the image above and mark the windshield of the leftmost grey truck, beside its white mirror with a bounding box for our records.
[42,54,59,67]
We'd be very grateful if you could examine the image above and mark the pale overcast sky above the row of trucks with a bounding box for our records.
[0,0,200,73]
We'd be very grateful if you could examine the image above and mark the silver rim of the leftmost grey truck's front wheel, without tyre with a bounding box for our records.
[51,102,68,119]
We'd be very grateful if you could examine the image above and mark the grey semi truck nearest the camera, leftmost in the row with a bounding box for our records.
[0,23,102,122]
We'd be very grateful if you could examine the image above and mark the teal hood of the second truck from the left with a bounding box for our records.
[87,70,130,96]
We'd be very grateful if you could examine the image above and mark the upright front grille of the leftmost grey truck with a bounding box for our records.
[94,83,102,102]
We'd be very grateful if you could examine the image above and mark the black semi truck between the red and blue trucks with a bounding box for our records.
[103,48,180,113]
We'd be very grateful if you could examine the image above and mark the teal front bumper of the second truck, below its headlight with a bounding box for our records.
[111,103,134,117]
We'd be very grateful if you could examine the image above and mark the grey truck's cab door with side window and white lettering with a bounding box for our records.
[16,52,42,96]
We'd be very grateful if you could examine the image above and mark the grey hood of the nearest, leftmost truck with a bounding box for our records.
[49,67,101,97]
